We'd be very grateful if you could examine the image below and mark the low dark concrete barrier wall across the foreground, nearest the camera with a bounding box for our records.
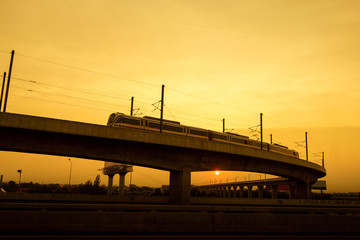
[0,211,360,234]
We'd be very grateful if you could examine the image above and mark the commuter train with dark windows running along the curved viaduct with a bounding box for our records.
[107,113,299,158]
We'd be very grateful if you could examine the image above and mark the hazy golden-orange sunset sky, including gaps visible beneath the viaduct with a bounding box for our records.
[0,0,360,191]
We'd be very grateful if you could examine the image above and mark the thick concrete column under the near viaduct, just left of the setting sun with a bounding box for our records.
[169,169,191,205]
